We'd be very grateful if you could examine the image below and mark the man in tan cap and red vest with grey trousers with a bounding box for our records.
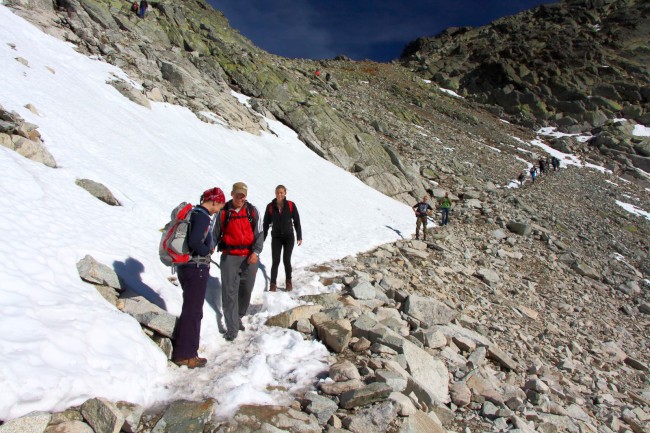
[214,182,264,341]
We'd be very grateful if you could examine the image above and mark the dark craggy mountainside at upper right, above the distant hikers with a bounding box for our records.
[401,0,650,171]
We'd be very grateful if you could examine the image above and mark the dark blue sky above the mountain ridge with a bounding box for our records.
[208,0,551,62]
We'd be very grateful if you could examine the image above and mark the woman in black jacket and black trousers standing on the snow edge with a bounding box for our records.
[264,185,302,292]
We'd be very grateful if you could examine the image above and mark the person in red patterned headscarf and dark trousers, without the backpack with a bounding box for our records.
[172,187,226,368]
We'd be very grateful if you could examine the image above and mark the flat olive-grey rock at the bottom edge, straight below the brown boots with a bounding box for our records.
[151,399,215,433]
